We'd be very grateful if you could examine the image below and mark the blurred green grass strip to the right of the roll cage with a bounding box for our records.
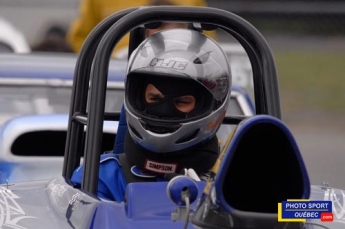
[274,50,345,113]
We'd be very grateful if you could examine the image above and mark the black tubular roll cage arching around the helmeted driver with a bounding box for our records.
[62,6,281,194]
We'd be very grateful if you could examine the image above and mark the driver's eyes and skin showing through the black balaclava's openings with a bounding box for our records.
[145,84,195,113]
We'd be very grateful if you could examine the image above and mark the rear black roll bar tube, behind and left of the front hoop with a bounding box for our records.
[62,7,138,178]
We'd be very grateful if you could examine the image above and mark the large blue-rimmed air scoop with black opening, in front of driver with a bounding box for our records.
[215,115,310,213]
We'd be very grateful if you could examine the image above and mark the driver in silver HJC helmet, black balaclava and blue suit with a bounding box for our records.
[72,29,231,202]
